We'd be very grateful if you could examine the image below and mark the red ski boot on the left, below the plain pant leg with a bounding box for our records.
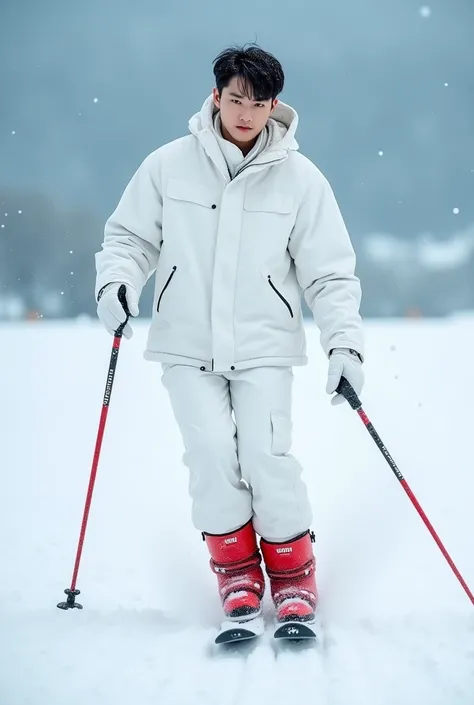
[203,521,265,622]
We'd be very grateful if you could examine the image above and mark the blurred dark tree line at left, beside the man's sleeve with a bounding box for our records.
[0,190,97,319]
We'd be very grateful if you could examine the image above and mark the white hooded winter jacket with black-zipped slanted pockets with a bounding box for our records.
[96,96,364,372]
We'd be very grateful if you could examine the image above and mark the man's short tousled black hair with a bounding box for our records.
[213,44,285,100]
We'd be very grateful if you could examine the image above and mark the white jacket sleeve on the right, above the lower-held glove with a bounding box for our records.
[288,171,364,358]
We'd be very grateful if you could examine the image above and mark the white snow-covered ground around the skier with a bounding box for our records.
[0,319,474,705]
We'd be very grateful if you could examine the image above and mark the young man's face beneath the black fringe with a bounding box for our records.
[213,77,278,146]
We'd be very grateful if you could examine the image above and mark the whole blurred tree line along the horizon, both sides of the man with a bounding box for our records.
[0,184,474,320]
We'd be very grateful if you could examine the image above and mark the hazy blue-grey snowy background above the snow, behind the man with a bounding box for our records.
[0,0,474,319]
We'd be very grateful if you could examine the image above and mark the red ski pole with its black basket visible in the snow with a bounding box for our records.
[57,284,130,610]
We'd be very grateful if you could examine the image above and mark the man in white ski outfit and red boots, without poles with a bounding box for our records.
[96,46,364,623]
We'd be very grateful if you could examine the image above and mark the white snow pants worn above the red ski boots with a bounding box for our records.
[162,364,312,541]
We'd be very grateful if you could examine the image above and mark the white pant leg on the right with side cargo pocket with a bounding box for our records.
[230,367,312,541]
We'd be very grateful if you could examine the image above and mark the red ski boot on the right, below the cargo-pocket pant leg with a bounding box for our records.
[260,531,318,624]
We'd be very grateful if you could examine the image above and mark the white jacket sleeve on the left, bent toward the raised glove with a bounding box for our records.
[95,152,163,299]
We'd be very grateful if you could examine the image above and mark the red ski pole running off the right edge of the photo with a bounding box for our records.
[336,377,474,605]
